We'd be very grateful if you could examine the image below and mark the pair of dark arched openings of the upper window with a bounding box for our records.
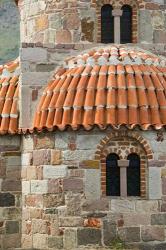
[101,4,132,43]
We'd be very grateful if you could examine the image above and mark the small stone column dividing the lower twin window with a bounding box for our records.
[118,160,129,197]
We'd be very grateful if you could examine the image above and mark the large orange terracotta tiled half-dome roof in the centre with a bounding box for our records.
[34,46,166,131]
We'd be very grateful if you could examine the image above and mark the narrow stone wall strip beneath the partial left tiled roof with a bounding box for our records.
[0,136,21,249]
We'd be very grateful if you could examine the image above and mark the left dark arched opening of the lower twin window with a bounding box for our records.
[106,154,120,196]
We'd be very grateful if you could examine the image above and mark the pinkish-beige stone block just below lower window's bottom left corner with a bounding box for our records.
[82,198,109,212]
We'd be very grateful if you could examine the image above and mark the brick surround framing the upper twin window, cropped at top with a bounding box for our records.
[93,0,145,43]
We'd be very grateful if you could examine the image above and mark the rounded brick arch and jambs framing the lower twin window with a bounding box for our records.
[95,131,153,198]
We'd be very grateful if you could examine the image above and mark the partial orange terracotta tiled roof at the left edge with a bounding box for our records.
[0,60,20,134]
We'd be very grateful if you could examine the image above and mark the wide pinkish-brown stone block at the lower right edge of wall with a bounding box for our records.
[141,226,165,242]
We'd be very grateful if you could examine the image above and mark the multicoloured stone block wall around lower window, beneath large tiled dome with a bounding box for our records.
[22,130,166,250]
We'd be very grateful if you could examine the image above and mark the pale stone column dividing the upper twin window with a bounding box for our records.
[112,9,123,44]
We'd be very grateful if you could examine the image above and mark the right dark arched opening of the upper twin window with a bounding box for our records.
[120,5,132,43]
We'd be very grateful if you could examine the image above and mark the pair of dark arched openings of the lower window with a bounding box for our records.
[106,153,140,196]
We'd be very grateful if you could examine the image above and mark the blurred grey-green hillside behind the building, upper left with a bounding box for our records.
[0,0,20,64]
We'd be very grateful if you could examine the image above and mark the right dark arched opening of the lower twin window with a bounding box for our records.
[127,154,140,196]
